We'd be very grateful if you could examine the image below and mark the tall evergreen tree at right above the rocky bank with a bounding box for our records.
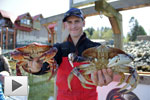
[128,17,146,41]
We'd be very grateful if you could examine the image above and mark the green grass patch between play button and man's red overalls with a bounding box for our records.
[28,74,54,100]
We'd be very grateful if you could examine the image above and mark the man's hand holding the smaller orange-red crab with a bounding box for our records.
[28,58,42,73]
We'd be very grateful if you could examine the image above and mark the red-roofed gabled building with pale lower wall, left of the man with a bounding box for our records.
[14,13,50,47]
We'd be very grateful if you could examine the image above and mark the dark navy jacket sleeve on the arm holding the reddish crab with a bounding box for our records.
[32,43,62,75]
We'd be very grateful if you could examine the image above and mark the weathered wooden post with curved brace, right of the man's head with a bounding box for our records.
[95,0,123,49]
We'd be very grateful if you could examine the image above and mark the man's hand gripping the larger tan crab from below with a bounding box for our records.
[92,69,113,86]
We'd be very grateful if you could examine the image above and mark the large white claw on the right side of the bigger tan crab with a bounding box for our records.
[107,54,133,67]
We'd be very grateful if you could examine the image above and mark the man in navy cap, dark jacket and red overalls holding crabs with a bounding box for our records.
[28,8,113,100]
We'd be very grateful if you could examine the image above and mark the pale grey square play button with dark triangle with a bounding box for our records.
[4,76,28,96]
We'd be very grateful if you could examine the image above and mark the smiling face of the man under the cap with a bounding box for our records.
[65,16,85,37]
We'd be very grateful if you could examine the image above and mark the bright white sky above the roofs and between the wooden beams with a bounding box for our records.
[0,0,150,36]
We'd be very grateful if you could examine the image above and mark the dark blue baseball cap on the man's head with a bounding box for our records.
[63,8,84,22]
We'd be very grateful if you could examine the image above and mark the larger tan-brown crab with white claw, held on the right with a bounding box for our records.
[67,45,139,92]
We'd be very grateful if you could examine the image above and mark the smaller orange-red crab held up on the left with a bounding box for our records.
[11,42,57,78]
